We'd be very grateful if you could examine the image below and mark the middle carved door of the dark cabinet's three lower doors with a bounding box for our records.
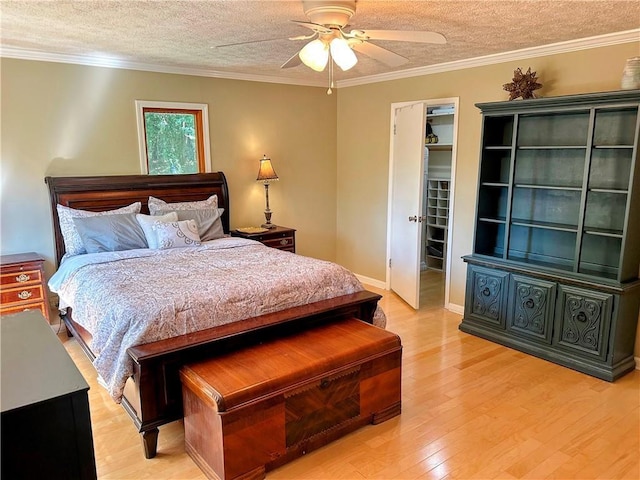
[507,275,556,343]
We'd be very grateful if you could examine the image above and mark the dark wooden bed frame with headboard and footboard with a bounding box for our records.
[45,172,381,458]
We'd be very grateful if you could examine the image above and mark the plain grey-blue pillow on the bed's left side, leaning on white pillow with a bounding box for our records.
[72,213,147,253]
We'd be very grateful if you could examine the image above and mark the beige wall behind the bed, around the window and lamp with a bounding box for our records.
[0,59,336,273]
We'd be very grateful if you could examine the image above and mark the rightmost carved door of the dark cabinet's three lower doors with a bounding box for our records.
[554,285,613,359]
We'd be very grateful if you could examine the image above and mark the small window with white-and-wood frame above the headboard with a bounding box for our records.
[136,100,211,175]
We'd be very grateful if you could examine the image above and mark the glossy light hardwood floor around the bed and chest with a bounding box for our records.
[59,271,640,480]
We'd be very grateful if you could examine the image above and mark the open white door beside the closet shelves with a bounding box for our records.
[389,103,427,309]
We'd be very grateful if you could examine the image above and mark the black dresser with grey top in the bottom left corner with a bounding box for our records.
[0,310,96,480]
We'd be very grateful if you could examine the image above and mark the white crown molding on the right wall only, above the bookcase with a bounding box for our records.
[336,28,640,88]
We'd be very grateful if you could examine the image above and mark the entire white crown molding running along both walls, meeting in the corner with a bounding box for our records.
[0,28,640,88]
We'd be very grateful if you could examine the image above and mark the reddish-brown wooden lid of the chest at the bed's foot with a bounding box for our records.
[180,318,402,412]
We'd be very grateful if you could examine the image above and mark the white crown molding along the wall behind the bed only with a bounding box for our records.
[0,45,326,87]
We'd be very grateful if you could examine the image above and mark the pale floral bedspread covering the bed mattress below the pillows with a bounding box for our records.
[49,237,386,402]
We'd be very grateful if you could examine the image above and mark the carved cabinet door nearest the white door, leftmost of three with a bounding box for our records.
[465,265,509,329]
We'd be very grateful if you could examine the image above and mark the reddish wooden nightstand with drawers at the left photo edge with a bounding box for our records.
[0,252,51,323]
